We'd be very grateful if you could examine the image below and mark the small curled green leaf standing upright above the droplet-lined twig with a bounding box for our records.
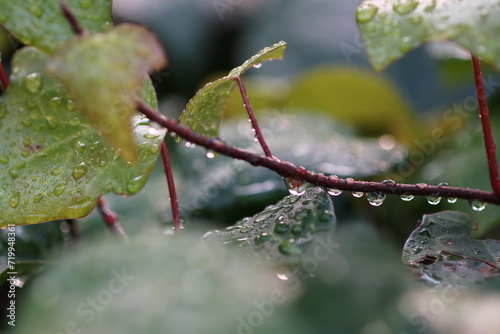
[177,41,286,143]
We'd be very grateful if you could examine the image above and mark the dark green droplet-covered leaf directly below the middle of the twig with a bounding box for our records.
[204,187,337,265]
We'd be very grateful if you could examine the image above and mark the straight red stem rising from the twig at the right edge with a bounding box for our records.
[472,55,500,195]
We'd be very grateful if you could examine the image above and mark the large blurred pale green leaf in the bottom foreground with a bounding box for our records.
[13,231,300,334]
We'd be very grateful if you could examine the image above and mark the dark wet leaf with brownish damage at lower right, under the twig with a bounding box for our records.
[402,211,500,285]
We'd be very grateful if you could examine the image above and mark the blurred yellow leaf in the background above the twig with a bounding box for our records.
[287,67,420,145]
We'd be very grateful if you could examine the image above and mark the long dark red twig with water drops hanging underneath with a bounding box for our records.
[137,102,500,204]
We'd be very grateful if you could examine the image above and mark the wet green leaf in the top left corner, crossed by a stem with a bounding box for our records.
[0,0,112,53]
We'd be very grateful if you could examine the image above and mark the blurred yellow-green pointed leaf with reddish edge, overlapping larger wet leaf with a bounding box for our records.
[47,24,167,163]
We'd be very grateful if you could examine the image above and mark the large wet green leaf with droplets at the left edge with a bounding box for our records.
[0,48,165,227]
